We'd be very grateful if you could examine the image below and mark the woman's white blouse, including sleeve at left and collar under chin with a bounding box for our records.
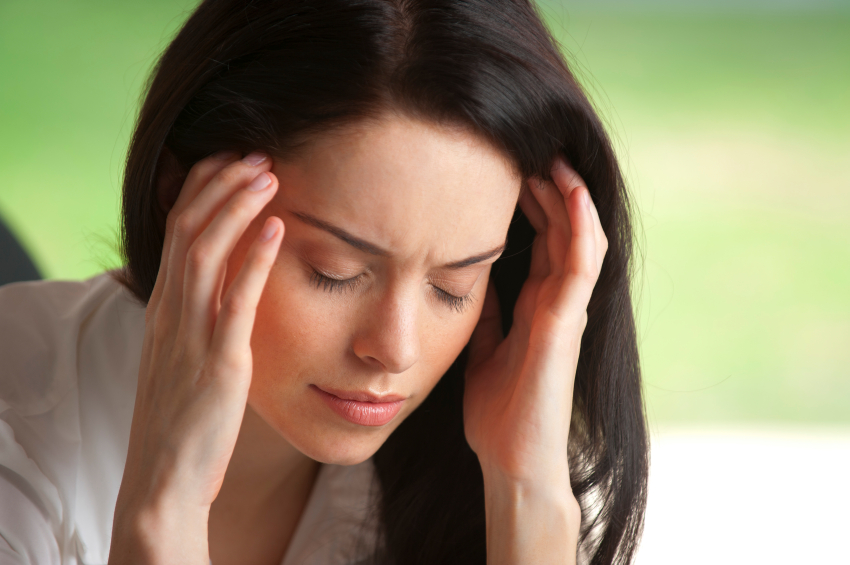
[0,274,376,565]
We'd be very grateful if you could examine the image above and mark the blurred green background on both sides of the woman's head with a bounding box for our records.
[0,0,850,429]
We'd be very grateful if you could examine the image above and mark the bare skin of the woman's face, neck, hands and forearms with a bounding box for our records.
[110,115,607,565]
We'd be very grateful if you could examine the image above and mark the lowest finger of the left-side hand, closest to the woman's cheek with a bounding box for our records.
[211,216,284,374]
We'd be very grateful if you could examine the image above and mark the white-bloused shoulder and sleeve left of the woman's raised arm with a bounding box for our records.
[0,273,144,563]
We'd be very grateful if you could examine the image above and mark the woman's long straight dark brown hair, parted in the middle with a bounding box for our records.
[116,0,648,565]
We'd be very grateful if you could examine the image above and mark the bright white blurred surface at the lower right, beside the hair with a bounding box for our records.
[636,428,850,565]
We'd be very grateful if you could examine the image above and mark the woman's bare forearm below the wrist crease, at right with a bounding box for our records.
[484,472,581,565]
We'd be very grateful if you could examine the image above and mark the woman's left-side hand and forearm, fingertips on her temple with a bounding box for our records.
[109,153,284,565]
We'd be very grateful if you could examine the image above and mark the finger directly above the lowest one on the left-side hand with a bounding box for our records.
[180,173,278,335]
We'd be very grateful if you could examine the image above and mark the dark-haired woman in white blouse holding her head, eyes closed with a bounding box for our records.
[0,0,647,565]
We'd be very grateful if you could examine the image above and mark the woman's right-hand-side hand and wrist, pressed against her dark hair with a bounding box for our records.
[464,158,608,564]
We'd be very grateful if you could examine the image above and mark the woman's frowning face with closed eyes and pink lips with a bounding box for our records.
[227,117,521,464]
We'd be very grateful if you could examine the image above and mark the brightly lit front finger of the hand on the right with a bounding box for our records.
[553,187,599,320]
